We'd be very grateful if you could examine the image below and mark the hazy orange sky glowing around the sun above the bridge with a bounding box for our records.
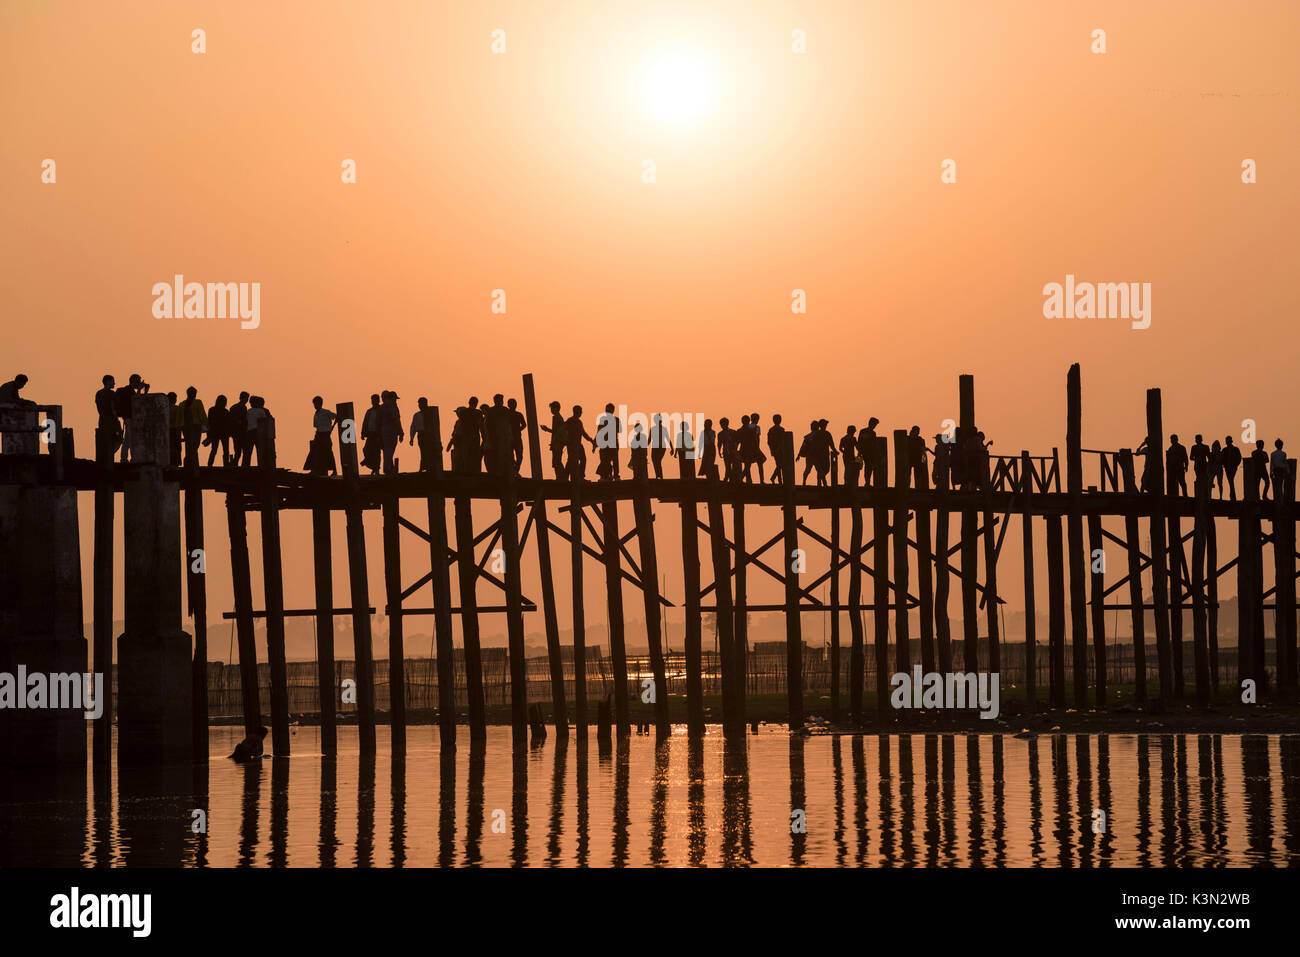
[0,0,1300,650]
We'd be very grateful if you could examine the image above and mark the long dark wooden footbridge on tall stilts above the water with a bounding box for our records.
[0,365,1296,780]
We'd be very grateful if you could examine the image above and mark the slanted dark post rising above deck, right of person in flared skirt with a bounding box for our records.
[335,402,374,753]
